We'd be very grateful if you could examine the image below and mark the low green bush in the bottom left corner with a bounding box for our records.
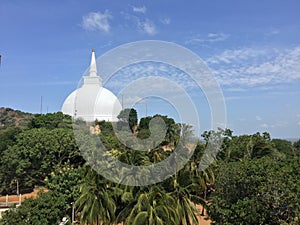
[0,192,66,225]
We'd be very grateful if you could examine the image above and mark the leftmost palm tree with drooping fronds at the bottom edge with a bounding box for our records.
[75,169,116,225]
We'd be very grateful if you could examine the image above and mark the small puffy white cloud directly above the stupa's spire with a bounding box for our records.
[82,10,113,33]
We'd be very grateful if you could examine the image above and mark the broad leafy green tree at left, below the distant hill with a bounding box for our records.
[0,128,82,192]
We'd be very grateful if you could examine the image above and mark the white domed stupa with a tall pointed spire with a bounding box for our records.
[61,49,122,122]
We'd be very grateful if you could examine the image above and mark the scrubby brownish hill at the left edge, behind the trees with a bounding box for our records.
[0,107,34,129]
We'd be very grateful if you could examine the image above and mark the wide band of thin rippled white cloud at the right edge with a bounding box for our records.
[207,46,300,86]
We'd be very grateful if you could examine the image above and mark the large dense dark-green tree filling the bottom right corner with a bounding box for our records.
[210,157,300,224]
